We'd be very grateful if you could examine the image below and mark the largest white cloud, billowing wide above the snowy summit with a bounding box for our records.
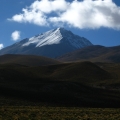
[8,0,120,30]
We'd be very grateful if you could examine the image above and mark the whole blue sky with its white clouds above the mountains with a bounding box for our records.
[0,0,120,49]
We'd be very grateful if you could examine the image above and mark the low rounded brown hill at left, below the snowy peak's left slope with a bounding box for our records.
[0,54,60,66]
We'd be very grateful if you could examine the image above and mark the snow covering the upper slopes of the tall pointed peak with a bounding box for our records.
[22,28,91,48]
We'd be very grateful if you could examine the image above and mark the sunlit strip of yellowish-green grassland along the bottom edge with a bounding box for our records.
[0,106,120,120]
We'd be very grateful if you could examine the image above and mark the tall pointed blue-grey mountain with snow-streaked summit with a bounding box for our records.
[0,28,92,58]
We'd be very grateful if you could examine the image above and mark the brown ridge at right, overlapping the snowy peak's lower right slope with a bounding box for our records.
[57,45,120,63]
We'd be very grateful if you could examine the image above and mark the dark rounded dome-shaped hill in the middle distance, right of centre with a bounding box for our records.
[48,62,110,83]
